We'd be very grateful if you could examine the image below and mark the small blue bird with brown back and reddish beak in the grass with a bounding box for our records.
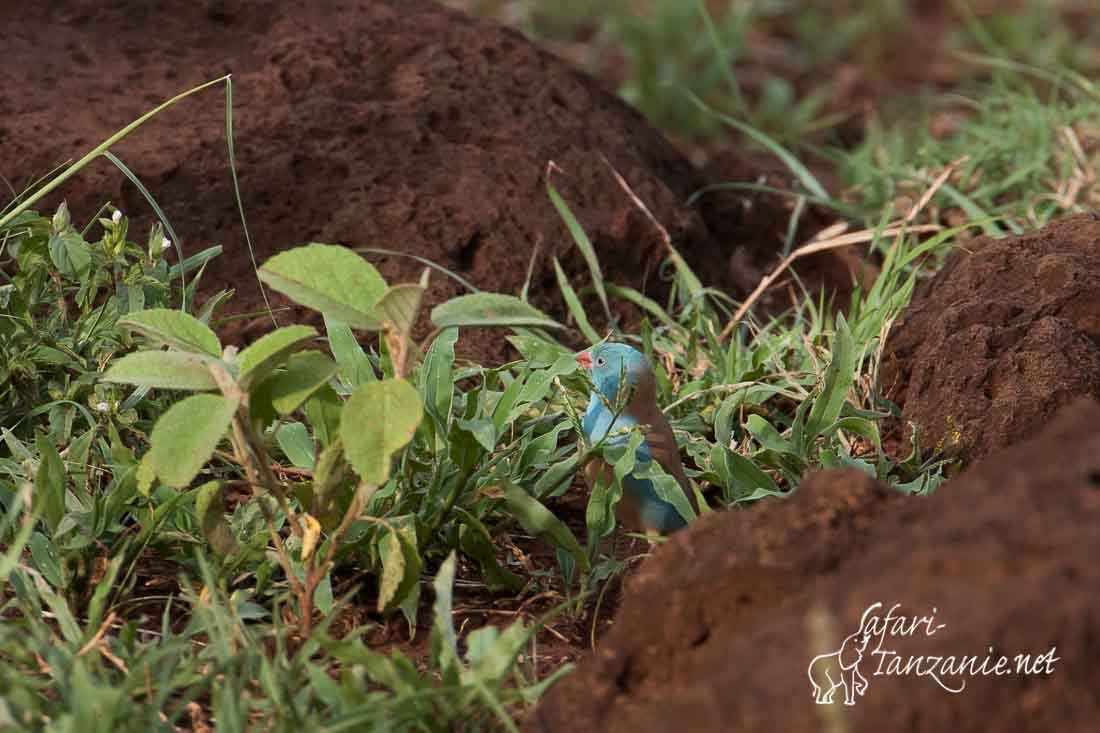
[576,343,694,535]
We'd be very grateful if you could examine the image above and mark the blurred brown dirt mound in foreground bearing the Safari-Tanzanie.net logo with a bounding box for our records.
[526,400,1100,732]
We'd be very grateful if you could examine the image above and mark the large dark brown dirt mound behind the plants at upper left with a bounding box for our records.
[0,0,774,355]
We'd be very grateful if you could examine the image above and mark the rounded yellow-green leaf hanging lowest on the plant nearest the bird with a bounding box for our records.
[340,380,424,486]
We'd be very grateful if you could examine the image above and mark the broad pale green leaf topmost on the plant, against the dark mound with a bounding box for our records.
[260,242,386,330]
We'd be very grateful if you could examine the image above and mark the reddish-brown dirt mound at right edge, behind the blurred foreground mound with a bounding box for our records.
[881,215,1100,459]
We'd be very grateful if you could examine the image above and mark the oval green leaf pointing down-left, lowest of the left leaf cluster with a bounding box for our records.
[150,394,238,489]
